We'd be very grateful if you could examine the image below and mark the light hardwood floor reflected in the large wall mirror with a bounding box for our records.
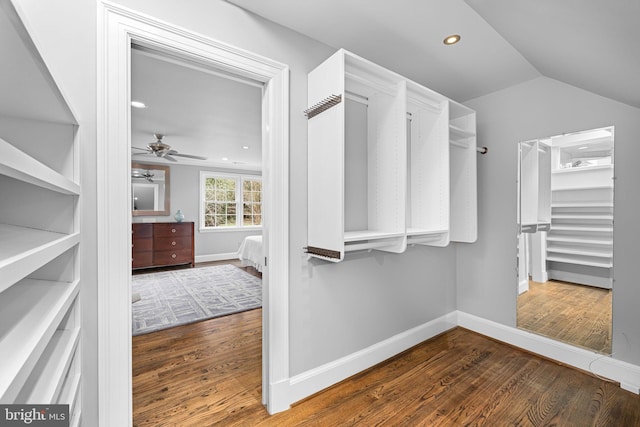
[518,280,612,354]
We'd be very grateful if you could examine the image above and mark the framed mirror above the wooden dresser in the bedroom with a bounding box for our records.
[131,163,171,216]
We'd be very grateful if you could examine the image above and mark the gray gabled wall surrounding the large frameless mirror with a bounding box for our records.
[456,77,640,365]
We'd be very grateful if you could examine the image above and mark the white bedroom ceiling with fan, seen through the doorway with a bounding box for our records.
[131,49,262,170]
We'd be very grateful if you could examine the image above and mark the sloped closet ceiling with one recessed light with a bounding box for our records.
[227,0,640,107]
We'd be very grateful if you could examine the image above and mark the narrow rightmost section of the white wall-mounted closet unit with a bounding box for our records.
[449,100,478,243]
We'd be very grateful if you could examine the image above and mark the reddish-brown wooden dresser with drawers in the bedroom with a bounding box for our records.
[131,222,194,269]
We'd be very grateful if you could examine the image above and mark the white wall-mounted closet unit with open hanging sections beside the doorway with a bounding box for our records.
[305,49,476,262]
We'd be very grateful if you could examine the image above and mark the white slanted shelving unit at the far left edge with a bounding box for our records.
[0,0,81,426]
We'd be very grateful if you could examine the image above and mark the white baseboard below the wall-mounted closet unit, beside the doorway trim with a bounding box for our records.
[288,312,457,403]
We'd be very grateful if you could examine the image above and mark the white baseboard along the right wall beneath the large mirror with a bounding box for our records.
[457,311,640,394]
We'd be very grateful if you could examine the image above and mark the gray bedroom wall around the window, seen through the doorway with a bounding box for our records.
[132,164,262,257]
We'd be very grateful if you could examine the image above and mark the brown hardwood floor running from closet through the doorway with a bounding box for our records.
[133,309,640,427]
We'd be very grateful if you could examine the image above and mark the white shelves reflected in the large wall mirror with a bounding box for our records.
[547,129,613,289]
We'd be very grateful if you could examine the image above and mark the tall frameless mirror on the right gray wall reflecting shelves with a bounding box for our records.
[517,127,614,354]
